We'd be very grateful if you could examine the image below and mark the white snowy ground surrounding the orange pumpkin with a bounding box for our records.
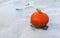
[0,0,60,38]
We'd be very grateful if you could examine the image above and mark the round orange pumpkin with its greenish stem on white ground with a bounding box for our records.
[30,8,49,27]
